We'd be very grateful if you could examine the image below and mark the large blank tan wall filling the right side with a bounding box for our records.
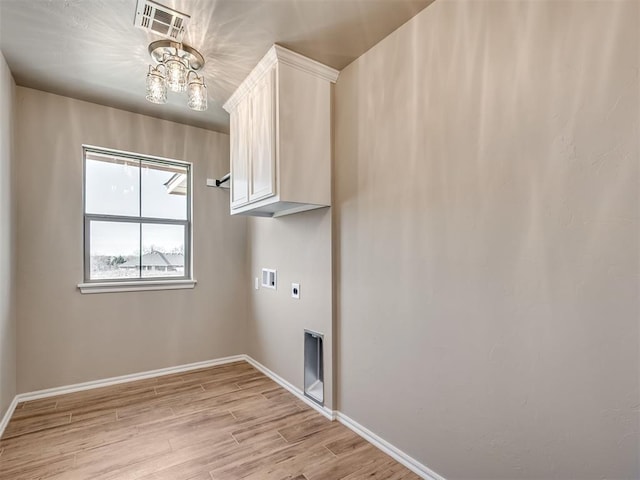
[334,0,640,479]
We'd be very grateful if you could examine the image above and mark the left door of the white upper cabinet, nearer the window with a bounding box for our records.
[229,97,251,208]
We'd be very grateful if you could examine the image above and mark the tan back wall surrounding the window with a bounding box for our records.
[16,87,247,392]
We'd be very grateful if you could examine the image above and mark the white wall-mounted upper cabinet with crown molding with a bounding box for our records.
[224,45,338,217]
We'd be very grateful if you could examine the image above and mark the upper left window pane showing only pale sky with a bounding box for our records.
[85,152,140,216]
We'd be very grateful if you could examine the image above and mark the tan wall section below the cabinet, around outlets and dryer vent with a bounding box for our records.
[247,208,334,408]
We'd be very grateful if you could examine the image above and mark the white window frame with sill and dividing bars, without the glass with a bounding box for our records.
[78,145,196,293]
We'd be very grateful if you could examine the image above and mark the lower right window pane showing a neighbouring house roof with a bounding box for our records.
[142,223,185,278]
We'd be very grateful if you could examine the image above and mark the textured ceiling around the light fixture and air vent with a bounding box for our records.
[0,0,433,132]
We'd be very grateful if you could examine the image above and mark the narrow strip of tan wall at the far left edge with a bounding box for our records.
[0,53,16,419]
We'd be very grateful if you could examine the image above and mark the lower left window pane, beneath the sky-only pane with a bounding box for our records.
[89,221,140,280]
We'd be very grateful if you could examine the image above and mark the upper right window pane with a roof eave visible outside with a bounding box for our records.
[142,162,188,220]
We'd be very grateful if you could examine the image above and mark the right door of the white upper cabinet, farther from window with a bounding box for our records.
[249,67,276,202]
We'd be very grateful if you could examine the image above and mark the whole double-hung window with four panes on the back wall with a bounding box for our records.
[80,146,193,291]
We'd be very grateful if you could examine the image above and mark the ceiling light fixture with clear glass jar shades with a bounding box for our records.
[147,40,207,111]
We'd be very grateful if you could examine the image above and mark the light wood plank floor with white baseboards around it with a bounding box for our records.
[0,362,419,480]
